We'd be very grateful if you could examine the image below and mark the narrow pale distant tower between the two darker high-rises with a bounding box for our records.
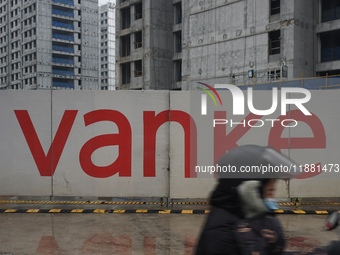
[99,3,116,90]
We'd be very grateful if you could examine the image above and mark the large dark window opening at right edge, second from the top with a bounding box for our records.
[320,30,340,62]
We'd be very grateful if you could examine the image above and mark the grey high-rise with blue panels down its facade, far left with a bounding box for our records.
[0,0,99,89]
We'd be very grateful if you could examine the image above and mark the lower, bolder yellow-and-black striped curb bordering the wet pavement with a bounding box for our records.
[0,208,340,215]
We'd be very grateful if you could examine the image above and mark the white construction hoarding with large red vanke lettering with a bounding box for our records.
[0,90,340,198]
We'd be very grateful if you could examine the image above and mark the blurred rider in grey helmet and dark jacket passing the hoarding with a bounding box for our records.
[195,145,340,255]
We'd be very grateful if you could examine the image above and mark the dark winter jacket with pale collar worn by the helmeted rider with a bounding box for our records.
[196,180,284,255]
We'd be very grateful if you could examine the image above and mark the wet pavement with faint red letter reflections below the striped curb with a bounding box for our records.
[0,213,337,255]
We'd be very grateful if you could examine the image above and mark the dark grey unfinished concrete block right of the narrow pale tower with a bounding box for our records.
[116,0,173,89]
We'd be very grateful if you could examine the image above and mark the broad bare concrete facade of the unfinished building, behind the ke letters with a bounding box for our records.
[182,0,318,89]
